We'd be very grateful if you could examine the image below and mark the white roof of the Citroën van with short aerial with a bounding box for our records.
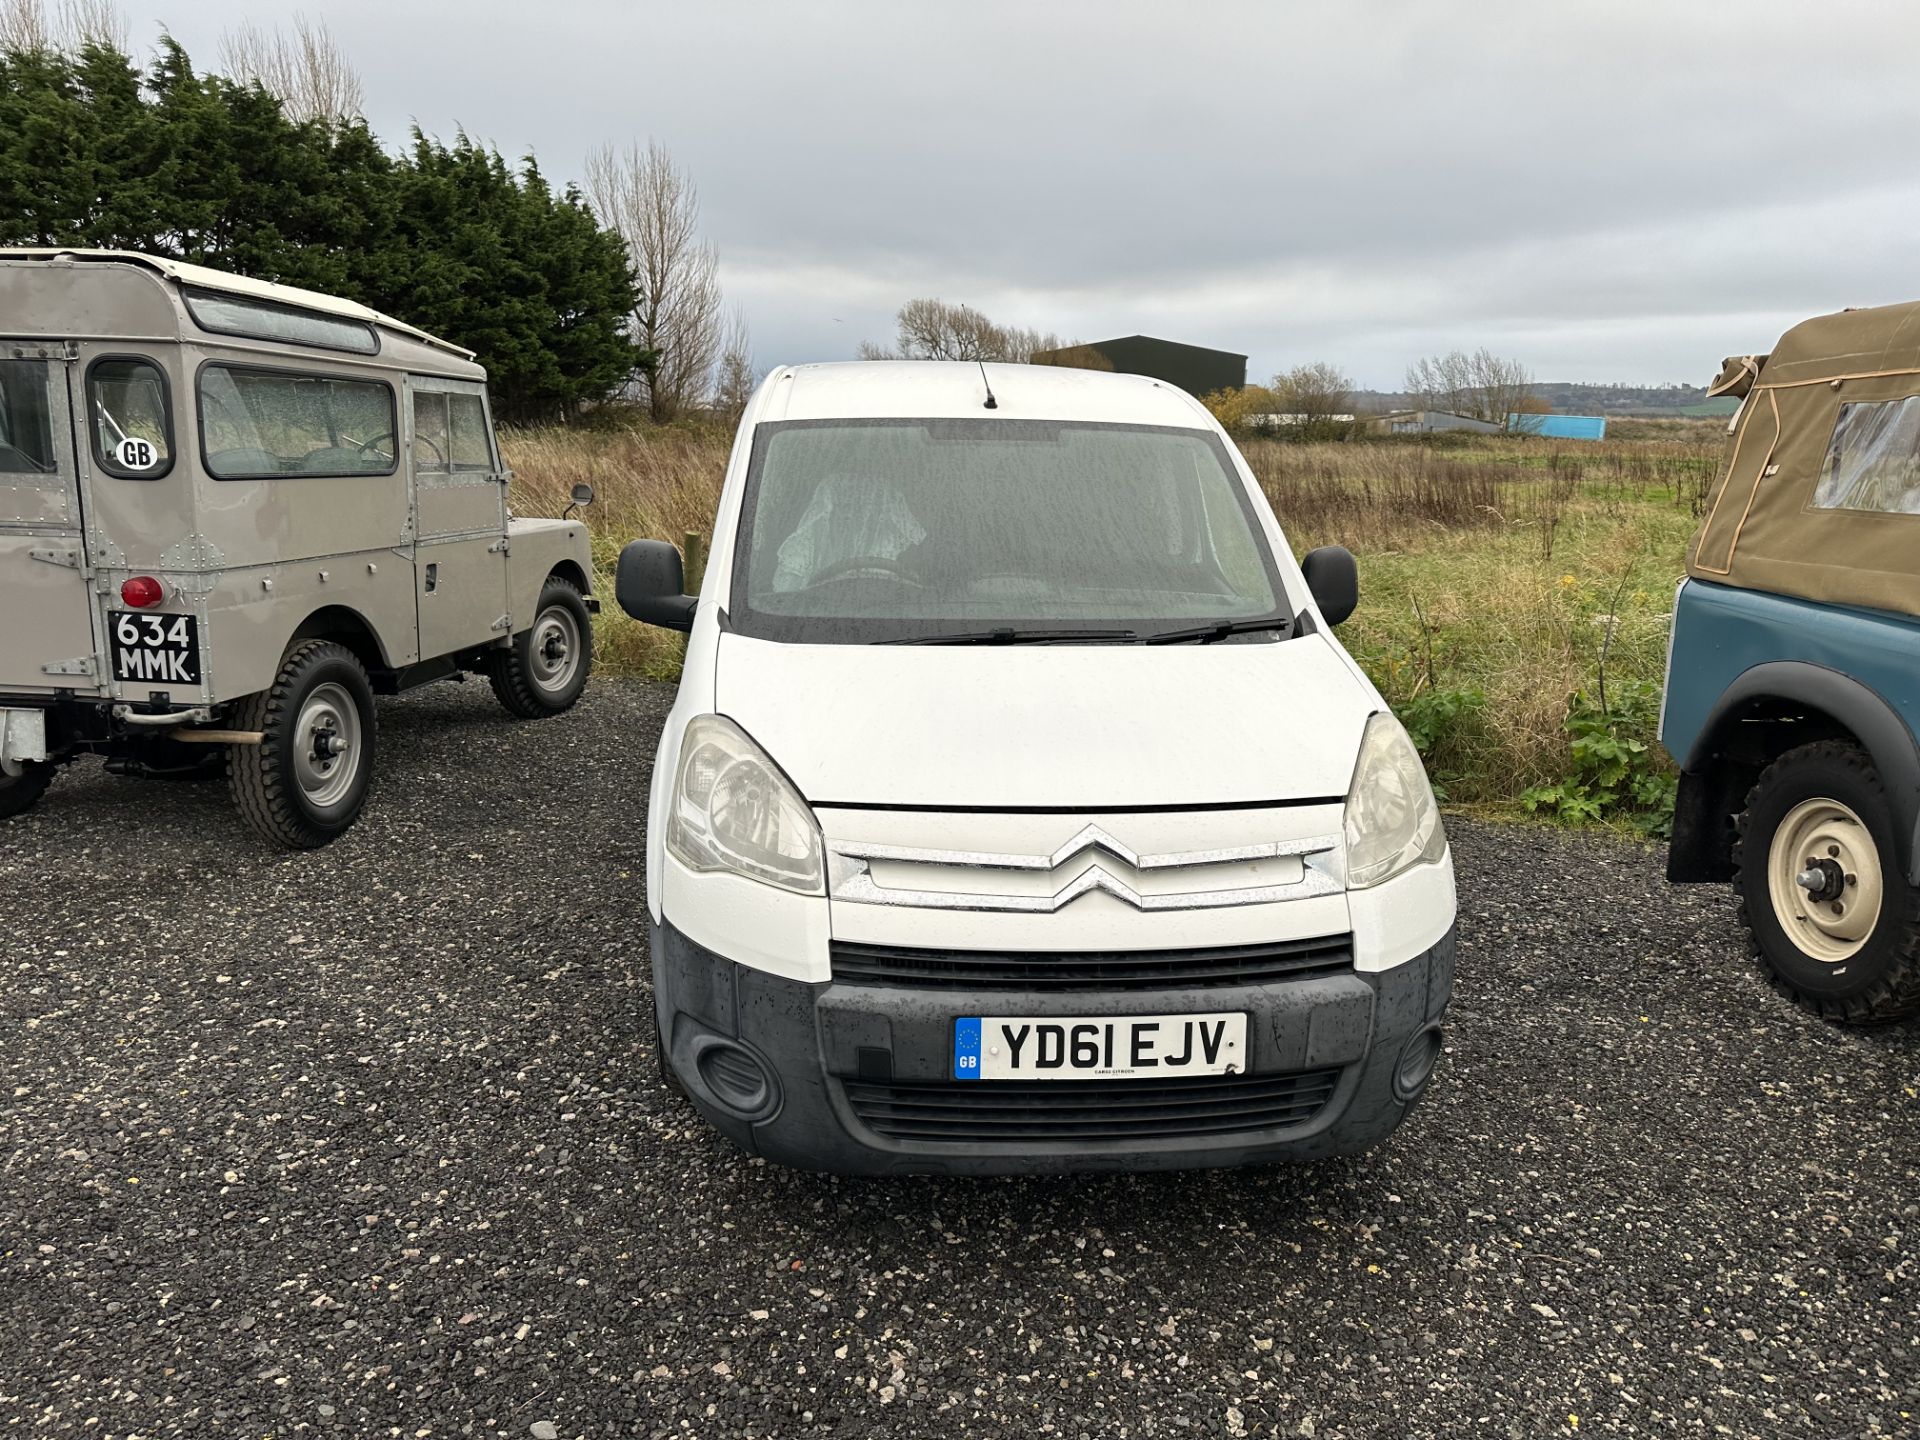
[755,361,1210,430]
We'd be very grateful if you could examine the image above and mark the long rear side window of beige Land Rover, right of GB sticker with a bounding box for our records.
[200,365,397,480]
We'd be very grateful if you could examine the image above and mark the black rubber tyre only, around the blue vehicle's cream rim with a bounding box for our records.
[1734,741,1920,1025]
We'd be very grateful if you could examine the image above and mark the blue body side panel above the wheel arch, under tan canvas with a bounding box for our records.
[1661,580,1920,764]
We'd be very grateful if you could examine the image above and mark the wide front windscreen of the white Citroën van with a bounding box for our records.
[730,419,1286,643]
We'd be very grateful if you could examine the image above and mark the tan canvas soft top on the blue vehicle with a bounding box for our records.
[1688,303,1920,614]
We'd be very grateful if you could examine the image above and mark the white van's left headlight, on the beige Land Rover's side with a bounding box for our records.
[666,714,826,895]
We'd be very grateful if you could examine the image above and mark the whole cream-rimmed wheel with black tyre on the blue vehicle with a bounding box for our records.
[1734,741,1920,1025]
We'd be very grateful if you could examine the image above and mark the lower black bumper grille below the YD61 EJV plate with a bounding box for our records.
[843,1069,1340,1144]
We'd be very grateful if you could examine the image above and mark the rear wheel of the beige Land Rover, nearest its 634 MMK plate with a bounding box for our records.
[227,639,374,851]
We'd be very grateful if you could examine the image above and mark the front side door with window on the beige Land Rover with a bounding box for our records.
[407,374,509,660]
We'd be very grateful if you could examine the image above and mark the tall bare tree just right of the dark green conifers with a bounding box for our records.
[588,140,722,424]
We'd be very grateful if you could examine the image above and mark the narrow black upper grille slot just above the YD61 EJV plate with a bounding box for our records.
[831,935,1354,991]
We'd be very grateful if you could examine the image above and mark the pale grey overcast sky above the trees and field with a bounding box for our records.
[123,0,1920,388]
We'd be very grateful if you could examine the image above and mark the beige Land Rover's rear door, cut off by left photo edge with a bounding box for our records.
[0,342,100,695]
